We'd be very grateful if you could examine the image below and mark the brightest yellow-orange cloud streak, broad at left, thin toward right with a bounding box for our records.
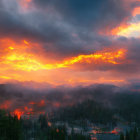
[1,40,125,71]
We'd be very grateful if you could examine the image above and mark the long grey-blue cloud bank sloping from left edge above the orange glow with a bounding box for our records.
[0,4,88,57]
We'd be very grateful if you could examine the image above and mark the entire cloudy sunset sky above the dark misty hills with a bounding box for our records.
[0,0,140,87]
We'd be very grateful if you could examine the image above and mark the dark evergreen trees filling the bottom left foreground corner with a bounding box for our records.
[0,110,91,140]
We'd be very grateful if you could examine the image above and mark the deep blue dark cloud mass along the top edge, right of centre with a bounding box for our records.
[34,0,135,30]
